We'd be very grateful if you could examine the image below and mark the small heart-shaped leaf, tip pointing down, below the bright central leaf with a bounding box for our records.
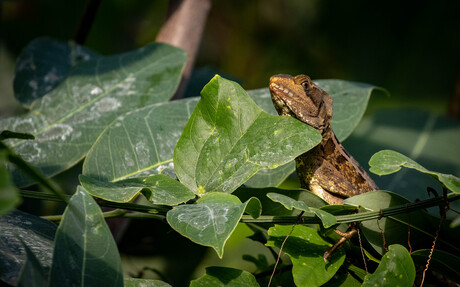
[166,192,261,258]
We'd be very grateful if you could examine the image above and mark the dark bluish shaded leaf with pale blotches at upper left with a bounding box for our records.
[13,38,98,106]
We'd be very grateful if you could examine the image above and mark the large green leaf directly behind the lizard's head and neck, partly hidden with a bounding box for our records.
[245,80,385,187]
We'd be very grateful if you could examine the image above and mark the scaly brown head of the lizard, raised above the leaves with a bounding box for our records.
[269,75,332,132]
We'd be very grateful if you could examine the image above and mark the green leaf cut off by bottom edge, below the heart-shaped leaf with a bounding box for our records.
[190,267,260,287]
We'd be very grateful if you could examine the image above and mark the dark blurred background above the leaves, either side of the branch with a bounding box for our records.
[0,0,460,113]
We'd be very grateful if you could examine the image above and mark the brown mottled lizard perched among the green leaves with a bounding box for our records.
[269,74,378,260]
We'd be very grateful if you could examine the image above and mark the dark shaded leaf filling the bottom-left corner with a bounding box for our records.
[0,210,56,285]
